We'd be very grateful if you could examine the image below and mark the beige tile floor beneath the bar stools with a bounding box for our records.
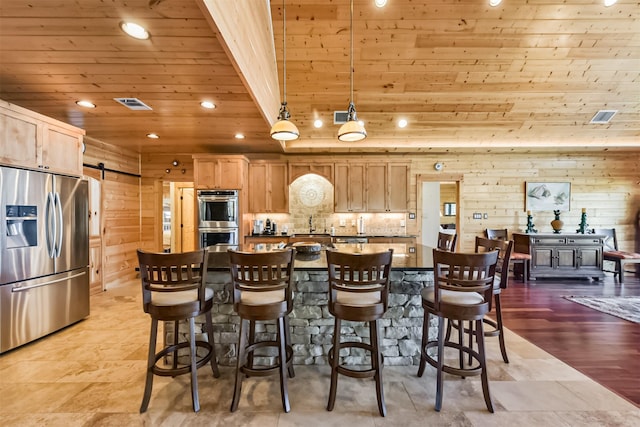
[0,282,640,427]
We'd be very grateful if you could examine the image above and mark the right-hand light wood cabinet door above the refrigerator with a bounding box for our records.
[40,125,82,176]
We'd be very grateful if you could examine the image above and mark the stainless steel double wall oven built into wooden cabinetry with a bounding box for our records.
[197,190,240,248]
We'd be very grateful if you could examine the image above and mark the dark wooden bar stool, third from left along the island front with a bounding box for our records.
[327,249,393,417]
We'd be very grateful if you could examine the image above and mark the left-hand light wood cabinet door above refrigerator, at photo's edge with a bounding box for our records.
[0,112,38,168]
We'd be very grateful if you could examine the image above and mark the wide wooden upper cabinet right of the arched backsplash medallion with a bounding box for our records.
[334,162,409,212]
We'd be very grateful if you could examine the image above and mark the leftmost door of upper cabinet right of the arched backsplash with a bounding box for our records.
[333,163,366,212]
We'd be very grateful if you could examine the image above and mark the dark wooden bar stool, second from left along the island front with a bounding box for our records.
[229,249,295,412]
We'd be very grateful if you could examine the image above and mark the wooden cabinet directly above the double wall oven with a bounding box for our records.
[193,155,247,190]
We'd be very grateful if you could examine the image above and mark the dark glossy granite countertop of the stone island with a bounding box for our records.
[209,243,433,271]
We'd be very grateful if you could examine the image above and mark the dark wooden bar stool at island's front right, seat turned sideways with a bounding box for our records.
[418,249,498,412]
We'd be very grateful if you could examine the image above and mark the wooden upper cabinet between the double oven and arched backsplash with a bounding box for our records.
[249,162,289,213]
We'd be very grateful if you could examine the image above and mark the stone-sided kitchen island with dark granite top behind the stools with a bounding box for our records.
[195,243,435,365]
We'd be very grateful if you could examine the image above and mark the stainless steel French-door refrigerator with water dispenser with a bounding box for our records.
[0,167,89,353]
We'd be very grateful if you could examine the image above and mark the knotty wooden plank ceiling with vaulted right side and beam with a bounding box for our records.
[0,0,640,153]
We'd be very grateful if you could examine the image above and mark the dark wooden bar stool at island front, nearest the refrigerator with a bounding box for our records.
[138,249,220,413]
